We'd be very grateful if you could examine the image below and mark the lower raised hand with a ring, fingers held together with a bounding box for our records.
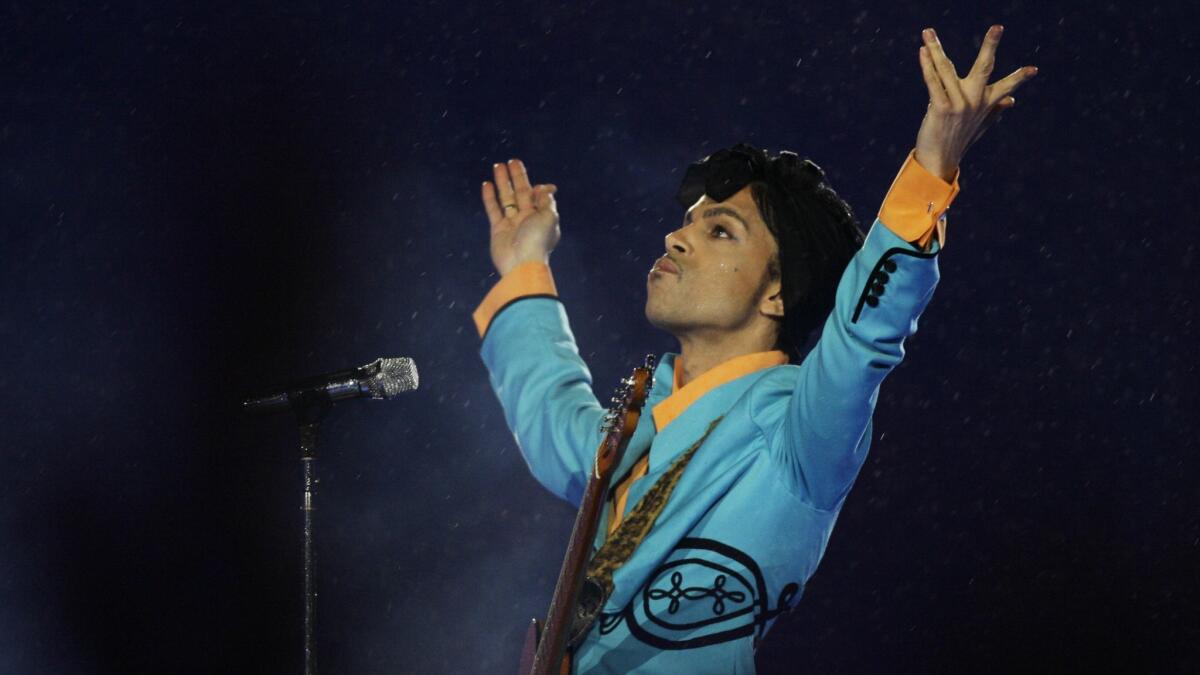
[482,160,560,276]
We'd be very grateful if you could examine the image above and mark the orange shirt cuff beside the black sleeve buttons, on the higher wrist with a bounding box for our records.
[880,150,961,250]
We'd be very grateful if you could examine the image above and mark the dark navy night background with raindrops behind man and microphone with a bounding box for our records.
[0,0,1200,674]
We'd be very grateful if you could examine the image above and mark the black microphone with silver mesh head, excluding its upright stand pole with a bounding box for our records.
[241,357,418,414]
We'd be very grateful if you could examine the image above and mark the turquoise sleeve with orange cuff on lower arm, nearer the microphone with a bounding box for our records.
[474,263,605,504]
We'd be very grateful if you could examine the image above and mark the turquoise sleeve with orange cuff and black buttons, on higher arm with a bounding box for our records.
[768,153,959,509]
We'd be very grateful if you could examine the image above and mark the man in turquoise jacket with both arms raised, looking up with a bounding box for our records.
[474,26,1037,673]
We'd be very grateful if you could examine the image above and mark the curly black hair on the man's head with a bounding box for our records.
[676,143,864,363]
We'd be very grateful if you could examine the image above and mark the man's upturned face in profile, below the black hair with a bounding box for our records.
[646,186,782,336]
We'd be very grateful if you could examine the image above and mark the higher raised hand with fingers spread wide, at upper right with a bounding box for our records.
[917,25,1038,183]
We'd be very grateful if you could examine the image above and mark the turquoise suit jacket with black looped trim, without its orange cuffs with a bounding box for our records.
[481,149,956,675]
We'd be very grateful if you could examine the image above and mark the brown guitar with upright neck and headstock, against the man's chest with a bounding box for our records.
[518,356,654,675]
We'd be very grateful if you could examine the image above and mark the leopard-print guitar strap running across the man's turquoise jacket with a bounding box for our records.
[568,416,725,649]
